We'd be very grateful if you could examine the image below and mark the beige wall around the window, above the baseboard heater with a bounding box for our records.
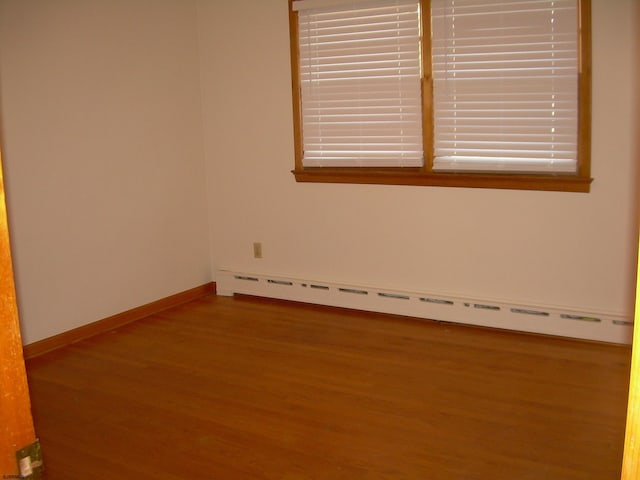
[198,0,639,320]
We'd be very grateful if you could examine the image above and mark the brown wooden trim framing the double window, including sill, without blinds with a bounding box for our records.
[289,0,593,193]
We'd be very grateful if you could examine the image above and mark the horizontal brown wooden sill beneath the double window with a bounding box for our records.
[292,167,593,193]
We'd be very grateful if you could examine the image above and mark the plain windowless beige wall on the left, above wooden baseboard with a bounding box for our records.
[0,0,211,344]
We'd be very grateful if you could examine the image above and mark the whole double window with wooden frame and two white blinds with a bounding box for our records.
[289,0,591,192]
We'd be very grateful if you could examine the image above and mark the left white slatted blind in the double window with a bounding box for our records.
[293,0,424,167]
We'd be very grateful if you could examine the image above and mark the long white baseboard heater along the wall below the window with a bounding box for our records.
[216,269,633,344]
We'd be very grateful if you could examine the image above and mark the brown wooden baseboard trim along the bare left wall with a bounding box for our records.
[23,282,216,359]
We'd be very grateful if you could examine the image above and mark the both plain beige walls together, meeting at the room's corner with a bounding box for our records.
[0,0,640,343]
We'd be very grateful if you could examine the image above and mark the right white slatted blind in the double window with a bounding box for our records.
[431,0,578,173]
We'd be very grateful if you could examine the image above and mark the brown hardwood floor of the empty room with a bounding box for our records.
[27,295,630,480]
